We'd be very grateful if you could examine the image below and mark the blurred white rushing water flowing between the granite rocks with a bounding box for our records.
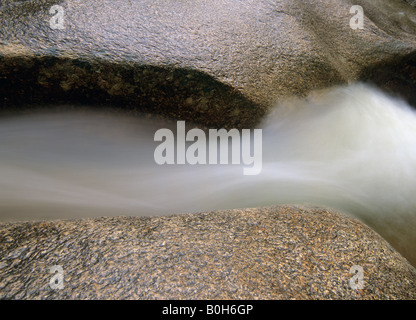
[0,84,416,262]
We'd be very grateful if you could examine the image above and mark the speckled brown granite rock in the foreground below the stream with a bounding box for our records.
[0,206,416,299]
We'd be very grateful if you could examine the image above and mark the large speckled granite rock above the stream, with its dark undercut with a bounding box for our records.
[0,0,416,128]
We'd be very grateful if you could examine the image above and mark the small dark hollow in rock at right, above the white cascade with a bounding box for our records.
[359,52,416,108]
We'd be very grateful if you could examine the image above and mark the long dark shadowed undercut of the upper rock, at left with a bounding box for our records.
[0,56,266,128]
